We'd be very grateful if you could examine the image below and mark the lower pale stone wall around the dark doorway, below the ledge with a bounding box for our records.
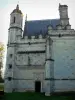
[13,66,45,91]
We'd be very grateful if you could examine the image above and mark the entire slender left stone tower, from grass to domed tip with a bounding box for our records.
[4,5,23,92]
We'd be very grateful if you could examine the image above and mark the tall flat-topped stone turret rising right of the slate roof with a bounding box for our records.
[59,4,70,28]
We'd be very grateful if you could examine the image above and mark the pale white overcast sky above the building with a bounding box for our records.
[0,0,75,75]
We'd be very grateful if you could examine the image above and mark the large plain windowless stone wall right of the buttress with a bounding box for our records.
[49,30,75,92]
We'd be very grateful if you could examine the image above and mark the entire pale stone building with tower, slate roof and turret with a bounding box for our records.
[4,4,75,95]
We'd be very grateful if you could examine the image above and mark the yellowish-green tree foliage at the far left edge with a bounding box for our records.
[0,42,4,82]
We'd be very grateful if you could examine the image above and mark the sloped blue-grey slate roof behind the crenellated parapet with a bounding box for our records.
[23,19,60,36]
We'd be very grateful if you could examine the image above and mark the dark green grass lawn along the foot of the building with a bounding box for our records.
[4,92,75,100]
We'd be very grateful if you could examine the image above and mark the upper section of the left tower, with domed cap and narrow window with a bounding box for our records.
[8,5,23,43]
